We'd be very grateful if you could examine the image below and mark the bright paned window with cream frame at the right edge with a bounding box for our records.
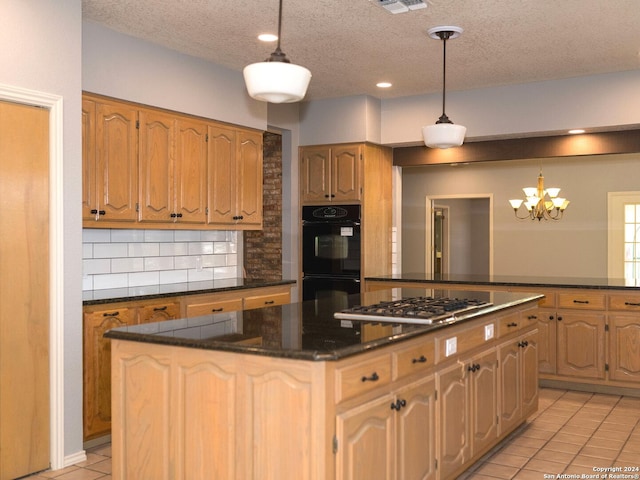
[608,192,640,285]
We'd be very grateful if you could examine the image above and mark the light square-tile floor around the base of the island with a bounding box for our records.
[28,388,640,480]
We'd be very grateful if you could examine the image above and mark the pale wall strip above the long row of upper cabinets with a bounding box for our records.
[82,22,267,130]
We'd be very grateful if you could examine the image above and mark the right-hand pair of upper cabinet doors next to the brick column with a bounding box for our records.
[207,125,262,229]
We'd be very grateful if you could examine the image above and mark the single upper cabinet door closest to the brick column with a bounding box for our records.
[236,130,262,227]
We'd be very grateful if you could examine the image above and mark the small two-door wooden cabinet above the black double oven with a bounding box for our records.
[300,144,363,204]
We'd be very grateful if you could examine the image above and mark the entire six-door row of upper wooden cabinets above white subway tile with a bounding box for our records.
[82,94,262,230]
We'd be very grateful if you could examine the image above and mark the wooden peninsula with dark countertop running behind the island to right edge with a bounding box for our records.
[365,273,640,397]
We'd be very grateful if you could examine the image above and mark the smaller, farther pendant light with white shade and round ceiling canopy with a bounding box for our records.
[422,27,467,148]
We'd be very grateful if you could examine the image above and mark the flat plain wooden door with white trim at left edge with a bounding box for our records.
[0,101,50,480]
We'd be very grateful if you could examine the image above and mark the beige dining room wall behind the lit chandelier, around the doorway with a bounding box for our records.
[402,154,640,278]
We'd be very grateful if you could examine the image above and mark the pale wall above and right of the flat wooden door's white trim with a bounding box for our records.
[0,0,82,462]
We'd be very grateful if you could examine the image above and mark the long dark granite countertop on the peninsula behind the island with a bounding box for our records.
[365,273,640,291]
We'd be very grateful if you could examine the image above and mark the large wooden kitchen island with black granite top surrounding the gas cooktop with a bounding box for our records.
[106,288,542,480]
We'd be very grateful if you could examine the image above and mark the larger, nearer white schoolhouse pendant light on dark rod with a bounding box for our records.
[243,0,311,103]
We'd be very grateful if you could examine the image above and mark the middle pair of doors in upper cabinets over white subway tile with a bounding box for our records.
[139,110,207,224]
